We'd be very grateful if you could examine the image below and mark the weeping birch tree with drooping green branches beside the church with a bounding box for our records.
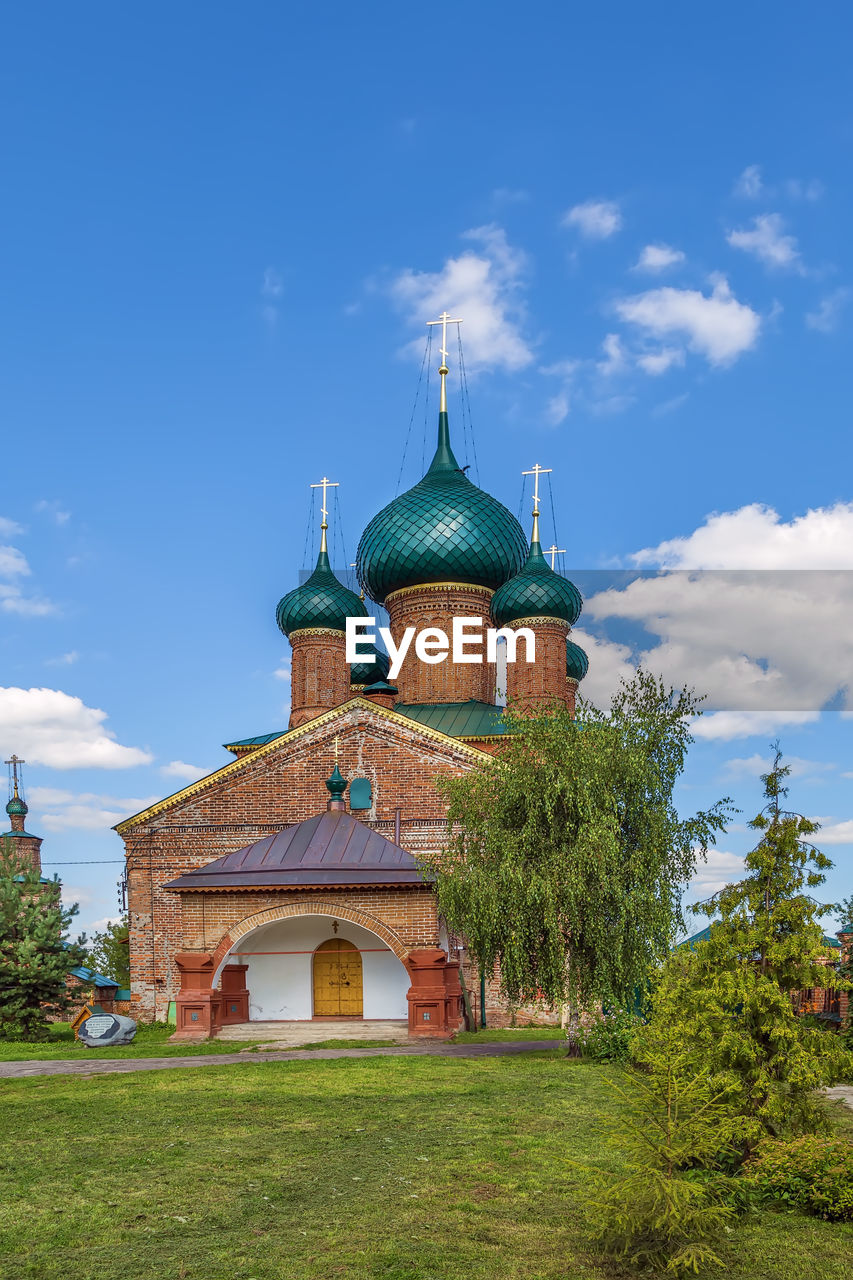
[429,671,731,1009]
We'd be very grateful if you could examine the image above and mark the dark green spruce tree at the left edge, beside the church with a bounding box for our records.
[0,838,86,1039]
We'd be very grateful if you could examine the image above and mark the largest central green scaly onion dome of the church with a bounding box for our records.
[356,412,526,604]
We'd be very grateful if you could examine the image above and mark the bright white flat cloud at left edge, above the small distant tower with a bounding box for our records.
[0,687,154,769]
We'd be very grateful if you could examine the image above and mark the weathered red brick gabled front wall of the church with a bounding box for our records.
[123,705,473,1018]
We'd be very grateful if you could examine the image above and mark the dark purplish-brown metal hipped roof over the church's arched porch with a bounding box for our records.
[164,809,424,893]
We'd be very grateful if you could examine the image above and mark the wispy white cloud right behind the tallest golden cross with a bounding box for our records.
[389,224,533,372]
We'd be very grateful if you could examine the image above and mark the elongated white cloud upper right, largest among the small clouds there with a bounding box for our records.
[616,278,761,365]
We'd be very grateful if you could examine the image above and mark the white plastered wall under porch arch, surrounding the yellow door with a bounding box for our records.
[216,915,411,1021]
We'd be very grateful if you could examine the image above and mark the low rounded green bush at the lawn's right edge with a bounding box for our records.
[744,1134,853,1222]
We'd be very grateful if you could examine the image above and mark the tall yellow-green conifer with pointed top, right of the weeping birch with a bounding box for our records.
[635,745,853,1157]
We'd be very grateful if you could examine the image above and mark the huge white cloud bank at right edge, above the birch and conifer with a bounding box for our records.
[585,503,853,741]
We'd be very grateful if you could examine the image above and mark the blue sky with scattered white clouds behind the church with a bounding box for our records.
[0,0,853,931]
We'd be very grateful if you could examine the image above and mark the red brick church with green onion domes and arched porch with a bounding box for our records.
[117,325,587,1038]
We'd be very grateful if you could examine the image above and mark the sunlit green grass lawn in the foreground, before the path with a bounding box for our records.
[0,1052,853,1280]
